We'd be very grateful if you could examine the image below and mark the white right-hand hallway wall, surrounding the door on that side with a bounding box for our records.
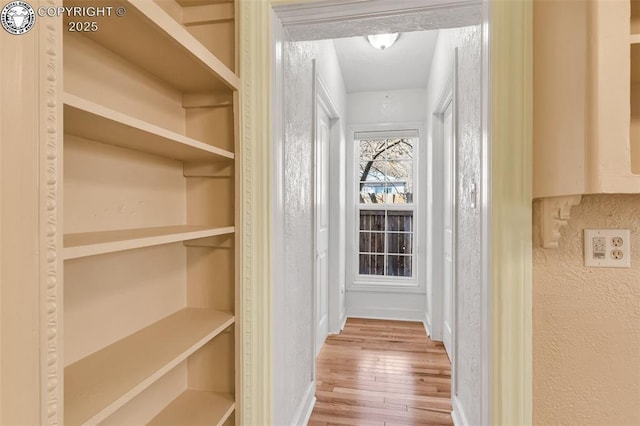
[426,26,482,425]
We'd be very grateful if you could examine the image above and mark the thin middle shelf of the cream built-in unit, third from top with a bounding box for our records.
[63,225,235,259]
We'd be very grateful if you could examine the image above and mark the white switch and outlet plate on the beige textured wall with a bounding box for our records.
[584,229,631,268]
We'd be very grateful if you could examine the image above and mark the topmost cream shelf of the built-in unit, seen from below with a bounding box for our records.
[65,0,240,92]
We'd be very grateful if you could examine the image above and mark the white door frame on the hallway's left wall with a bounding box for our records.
[312,59,340,356]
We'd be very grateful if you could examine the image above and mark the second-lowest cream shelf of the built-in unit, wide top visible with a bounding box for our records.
[64,308,234,425]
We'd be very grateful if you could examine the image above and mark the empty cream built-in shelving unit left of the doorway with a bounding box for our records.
[63,0,239,425]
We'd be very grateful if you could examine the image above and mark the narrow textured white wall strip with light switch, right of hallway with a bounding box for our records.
[455,26,482,425]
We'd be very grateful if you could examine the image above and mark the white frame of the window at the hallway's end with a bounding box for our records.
[346,123,426,293]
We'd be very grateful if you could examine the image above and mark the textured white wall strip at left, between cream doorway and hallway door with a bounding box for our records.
[273,42,314,425]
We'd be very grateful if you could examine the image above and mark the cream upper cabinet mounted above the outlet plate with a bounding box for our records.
[533,0,640,197]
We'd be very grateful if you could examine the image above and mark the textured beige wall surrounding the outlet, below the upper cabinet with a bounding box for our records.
[533,195,640,425]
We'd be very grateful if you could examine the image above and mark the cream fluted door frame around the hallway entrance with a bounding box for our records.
[238,0,533,425]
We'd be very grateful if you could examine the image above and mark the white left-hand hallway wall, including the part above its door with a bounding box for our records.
[273,33,346,426]
